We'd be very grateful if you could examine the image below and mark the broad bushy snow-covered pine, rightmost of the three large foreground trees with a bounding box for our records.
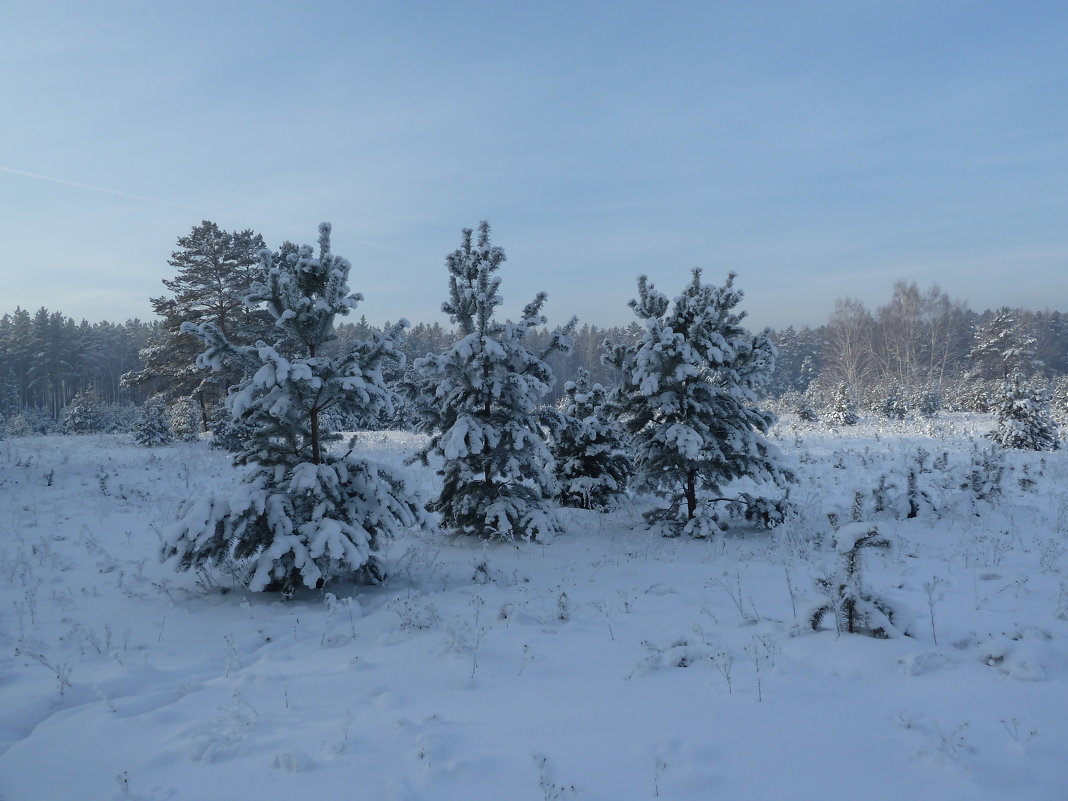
[606,269,791,536]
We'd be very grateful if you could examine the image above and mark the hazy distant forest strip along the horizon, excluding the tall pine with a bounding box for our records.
[0,285,1068,429]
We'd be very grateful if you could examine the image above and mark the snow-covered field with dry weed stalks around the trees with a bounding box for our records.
[0,415,1068,801]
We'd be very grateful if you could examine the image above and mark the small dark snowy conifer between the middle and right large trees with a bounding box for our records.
[552,367,634,509]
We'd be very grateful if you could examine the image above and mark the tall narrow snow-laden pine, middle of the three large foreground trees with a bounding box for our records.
[406,222,575,539]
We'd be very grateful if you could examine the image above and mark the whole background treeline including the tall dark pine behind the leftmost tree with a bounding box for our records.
[0,221,1068,431]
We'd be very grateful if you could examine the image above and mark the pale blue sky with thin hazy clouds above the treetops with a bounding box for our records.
[0,0,1068,327]
